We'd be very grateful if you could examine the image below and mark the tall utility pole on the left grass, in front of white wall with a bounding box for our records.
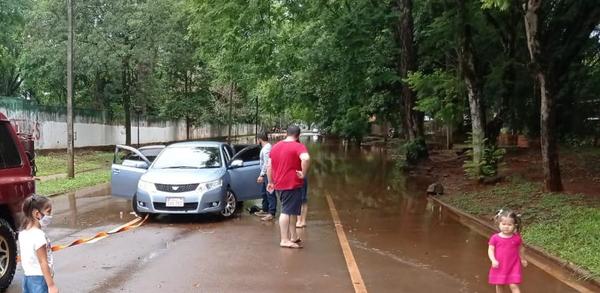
[67,0,75,178]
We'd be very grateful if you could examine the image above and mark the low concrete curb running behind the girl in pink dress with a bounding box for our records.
[429,196,600,292]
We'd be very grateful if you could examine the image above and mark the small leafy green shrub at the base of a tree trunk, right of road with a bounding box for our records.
[463,141,506,179]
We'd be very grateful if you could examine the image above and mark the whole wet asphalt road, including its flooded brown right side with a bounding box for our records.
[7,143,575,293]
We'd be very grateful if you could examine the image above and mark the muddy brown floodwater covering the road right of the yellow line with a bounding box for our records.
[309,138,576,292]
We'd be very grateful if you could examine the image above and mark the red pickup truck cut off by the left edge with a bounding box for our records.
[0,113,35,291]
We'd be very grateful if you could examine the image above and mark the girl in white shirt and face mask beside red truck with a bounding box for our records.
[19,195,58,293]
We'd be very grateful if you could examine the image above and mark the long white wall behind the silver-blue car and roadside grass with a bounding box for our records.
[0,105,254,150]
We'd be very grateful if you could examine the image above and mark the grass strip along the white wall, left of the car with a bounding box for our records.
[35,151,113,176]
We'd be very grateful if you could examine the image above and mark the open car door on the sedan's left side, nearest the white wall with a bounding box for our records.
[110,145,150,199]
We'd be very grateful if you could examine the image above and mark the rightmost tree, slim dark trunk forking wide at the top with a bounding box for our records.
[524,0,600,191]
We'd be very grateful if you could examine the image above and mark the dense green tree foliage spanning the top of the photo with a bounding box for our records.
[0,0,600,146]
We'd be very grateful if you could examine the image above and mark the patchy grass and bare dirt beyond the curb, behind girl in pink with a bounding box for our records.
[444,178,600,277]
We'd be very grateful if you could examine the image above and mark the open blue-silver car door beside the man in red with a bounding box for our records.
[228,145,262,201]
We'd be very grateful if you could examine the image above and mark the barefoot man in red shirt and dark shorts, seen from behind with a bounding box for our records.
[267,125,310,248]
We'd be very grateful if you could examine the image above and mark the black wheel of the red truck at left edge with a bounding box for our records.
[0,218,17,291]
